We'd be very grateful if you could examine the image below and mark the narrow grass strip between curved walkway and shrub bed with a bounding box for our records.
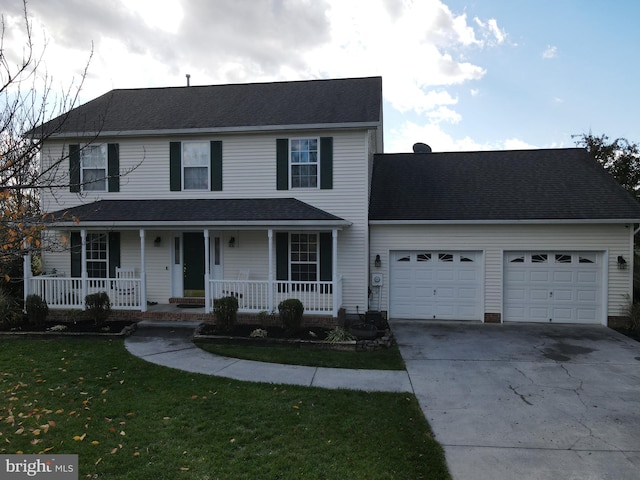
[196,340,405,370]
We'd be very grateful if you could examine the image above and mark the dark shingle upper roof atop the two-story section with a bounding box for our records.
[29,77,382,136]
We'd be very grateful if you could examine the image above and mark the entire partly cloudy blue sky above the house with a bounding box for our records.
[1,0,640,152]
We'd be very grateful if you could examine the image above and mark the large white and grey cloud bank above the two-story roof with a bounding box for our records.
[7,0,508,150]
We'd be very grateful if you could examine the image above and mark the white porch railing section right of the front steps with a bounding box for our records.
[209,277,342,316]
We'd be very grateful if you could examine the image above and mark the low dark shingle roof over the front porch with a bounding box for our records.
[47,198,351,229]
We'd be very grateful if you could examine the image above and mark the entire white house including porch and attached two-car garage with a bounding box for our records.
[25,77,640,325]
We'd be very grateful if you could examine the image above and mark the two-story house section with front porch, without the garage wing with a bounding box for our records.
[25,77,382,317]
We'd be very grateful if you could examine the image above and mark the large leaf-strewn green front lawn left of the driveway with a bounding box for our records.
[0,338,449,480]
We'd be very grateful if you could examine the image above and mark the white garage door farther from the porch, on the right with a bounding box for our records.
[504,252,603,323]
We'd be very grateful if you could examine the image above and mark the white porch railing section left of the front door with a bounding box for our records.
[28,275,142,310]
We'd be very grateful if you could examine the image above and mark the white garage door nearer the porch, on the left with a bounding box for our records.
[389,251,482,320]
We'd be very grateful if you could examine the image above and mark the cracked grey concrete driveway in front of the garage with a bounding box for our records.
[391,321,640,480]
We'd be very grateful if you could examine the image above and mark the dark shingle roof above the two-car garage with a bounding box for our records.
[369,148,640,221]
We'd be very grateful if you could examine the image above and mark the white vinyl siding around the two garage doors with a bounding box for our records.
[369,224,633,323]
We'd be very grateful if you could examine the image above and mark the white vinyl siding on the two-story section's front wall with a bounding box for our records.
[42,130,376,312]
